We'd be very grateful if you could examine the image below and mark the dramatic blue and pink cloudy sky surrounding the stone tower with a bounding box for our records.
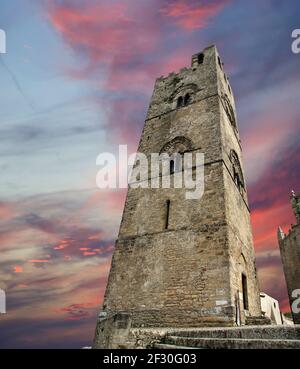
[0,0,300,348]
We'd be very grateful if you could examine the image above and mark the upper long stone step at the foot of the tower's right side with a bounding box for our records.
[168,325,300,340]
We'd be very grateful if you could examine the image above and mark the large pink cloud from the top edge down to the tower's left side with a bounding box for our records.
[47,0,227,147]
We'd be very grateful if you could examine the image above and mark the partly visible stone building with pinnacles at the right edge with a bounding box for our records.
[278,191,300,324]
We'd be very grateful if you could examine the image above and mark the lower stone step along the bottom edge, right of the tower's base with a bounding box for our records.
[164,336,300,349]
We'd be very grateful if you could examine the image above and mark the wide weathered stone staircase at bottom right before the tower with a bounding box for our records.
[154,325,300,349]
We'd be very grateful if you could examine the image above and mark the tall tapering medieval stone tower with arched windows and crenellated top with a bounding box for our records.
[94,46,261,347]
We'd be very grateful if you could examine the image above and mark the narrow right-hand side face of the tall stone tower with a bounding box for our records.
[218,53,261,322]
